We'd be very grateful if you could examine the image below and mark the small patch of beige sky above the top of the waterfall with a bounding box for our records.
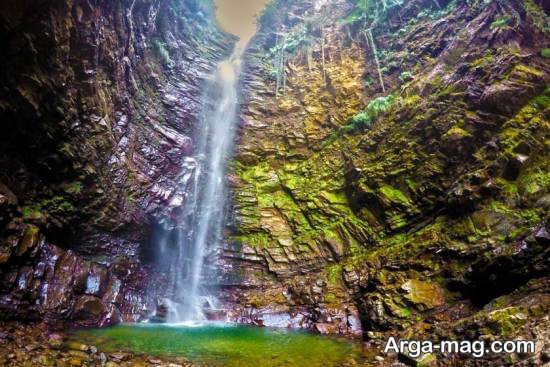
[214,0,269,48]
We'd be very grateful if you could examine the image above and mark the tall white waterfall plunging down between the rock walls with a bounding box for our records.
[155,50,241,322]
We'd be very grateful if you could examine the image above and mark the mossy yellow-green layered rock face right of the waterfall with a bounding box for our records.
[223,1,550,364]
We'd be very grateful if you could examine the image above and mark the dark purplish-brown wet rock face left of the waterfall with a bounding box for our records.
[0,0,234,326]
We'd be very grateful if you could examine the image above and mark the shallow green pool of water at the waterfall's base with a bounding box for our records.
[71,323,367,367]
